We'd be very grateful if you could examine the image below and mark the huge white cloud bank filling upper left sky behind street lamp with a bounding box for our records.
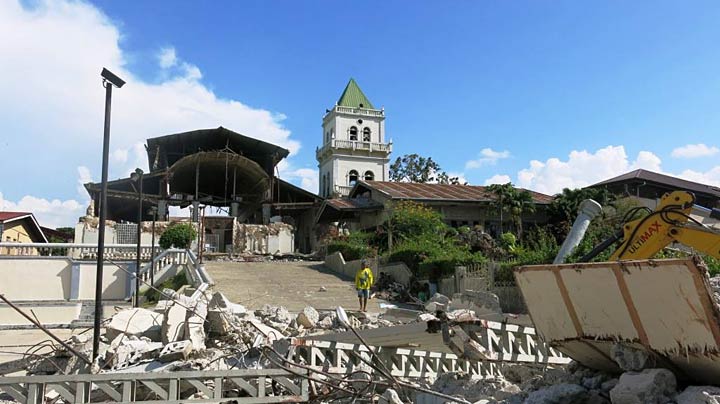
[0,0,306,225]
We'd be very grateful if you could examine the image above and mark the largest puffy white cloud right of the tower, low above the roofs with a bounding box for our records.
[517,146,661,194]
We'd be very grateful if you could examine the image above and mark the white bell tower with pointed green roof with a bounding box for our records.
[316,79,392,198]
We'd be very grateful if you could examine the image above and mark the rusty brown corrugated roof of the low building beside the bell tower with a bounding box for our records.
[355,181,553,204]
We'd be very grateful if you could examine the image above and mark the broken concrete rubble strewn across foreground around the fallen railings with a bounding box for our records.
[9,278,720,404]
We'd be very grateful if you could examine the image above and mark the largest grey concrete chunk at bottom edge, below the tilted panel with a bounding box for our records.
[610,369,677,404]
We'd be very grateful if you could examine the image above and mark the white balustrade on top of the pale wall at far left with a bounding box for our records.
[0,243,161,261]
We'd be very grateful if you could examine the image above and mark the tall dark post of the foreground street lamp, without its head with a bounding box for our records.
[92,82,112,362]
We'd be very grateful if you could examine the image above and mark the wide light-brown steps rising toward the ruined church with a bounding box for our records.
[205,261,384,312]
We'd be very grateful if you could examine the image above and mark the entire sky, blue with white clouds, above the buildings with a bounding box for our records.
[0,0,720,224]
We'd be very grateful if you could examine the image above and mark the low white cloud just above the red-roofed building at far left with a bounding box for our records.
[0,192,86,228]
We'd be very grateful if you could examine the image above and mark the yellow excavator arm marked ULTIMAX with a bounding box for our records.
[610,191,720,261]
